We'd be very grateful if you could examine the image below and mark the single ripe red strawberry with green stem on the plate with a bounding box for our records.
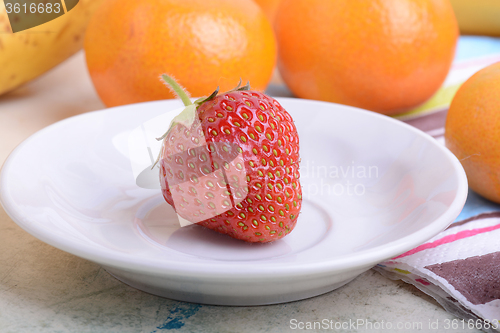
[159,75,302,243]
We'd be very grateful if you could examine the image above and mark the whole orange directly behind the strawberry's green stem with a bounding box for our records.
[84,0,276,106]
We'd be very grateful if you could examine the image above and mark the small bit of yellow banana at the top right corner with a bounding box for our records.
[451,0,500,36]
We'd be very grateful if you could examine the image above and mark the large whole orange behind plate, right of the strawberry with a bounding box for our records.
[274,0,458,114]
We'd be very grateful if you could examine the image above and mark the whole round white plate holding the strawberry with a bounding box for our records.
[0,98,467,305]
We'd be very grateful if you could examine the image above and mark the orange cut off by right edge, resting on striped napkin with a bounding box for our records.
[444,62,500,203]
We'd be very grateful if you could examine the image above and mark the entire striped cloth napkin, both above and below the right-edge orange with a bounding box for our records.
[374,36,500,332]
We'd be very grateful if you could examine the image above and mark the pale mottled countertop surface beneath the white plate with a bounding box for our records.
[0,52,479,333]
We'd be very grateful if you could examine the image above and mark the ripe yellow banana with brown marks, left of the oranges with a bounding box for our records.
[0,0,103,95]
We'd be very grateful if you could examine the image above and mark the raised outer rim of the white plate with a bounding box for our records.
[0,97,468,279]
